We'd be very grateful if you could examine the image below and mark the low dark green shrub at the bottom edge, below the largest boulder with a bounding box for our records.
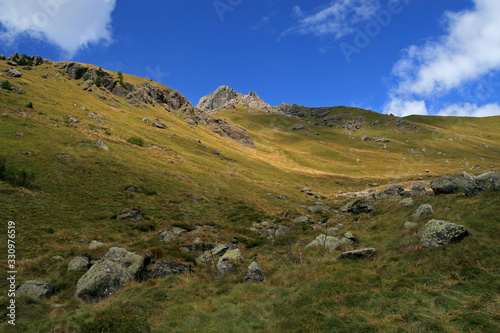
[81,311,151,333]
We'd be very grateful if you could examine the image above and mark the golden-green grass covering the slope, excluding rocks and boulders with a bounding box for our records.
[0,62,500,332]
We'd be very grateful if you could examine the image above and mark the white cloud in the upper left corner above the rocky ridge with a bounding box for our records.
[0,0,116,57]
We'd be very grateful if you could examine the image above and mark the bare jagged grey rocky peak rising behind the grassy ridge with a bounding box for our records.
[197,86,270,113]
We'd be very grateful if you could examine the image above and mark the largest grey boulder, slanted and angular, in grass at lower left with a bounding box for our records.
[75,247,144,304]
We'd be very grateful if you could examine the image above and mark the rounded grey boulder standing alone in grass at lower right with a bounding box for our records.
[418,220,469,249]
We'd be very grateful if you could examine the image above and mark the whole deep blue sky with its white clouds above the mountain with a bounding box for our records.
[0,0,500,117]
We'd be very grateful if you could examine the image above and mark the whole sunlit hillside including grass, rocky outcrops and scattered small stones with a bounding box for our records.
[0,57,500,332]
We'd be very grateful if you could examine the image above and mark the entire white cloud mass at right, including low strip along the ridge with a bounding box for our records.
[384,0,500,117]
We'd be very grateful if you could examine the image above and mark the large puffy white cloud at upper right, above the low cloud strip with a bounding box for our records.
[393,0,500,96]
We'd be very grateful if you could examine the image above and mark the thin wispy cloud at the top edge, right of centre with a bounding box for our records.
[282,0,380,39]
